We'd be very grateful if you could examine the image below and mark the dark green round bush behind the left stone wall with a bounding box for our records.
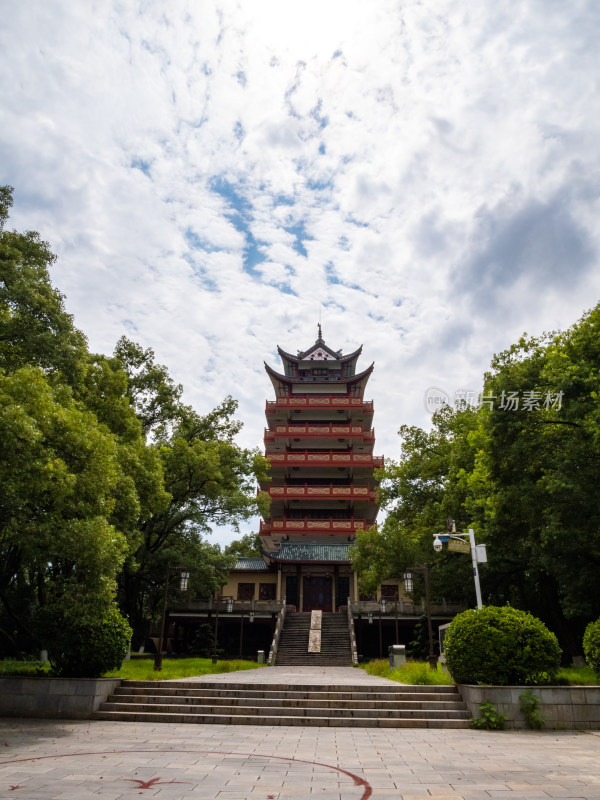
[48,607,132,678]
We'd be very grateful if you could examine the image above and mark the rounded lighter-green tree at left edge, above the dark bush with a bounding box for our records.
[0,367,127,638]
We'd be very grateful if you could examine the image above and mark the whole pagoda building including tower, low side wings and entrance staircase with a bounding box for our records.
[162,325,457,665]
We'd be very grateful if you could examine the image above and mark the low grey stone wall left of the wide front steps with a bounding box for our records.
[0,676,121,719]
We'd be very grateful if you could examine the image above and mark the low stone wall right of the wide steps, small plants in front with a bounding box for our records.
[458,684,600,730]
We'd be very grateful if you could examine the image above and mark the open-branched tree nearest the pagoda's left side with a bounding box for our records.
[111,338,268,643]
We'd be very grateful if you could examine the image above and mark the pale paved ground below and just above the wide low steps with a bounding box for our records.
[0,668,600,800]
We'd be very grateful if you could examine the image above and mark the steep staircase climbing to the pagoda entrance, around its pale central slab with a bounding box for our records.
[275,611,352,667]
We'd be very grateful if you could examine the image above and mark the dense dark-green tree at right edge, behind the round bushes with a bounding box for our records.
[477,307,600,655]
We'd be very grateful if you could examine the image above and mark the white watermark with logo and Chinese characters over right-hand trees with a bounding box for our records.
[425,386,564,414]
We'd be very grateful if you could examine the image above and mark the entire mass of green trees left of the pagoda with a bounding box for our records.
[0,187,266,649]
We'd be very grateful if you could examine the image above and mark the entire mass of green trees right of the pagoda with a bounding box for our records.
[353,306,600,655]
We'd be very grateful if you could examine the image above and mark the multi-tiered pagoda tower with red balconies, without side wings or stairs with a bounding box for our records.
[260,325,383,611]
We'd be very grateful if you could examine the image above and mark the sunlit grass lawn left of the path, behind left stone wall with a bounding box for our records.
[0,658,264,681]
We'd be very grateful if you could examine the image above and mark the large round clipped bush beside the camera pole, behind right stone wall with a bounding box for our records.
[444,606,561,686]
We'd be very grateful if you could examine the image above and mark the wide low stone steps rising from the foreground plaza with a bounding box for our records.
[94,680,470,728]
